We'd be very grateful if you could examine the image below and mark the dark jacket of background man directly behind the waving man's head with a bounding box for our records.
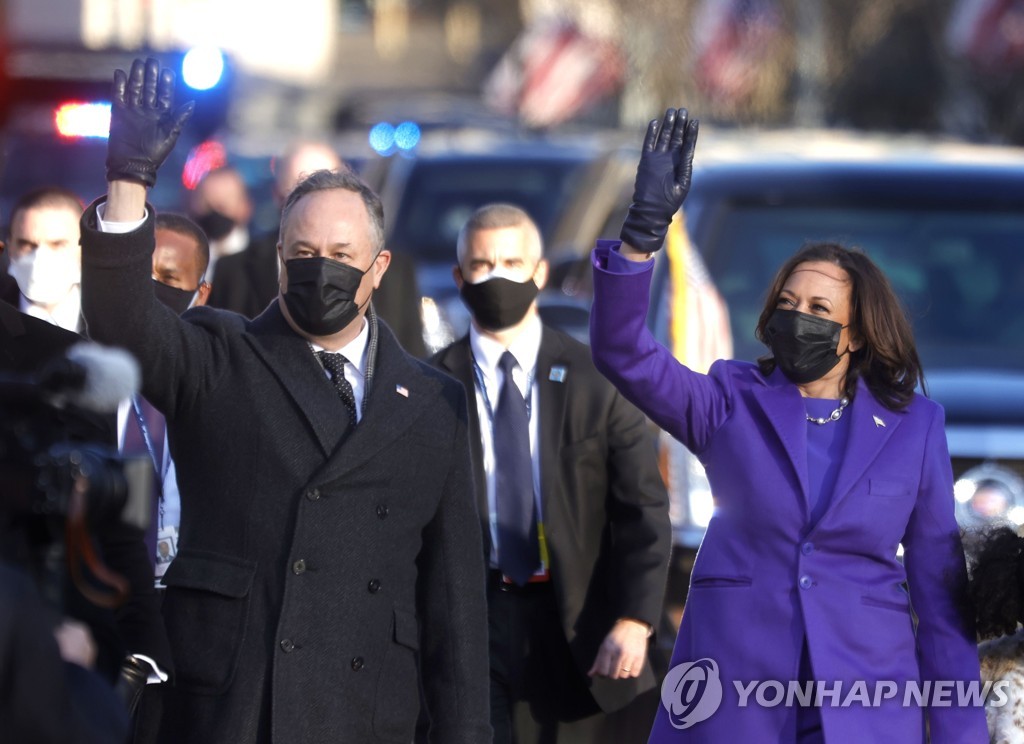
[207,231,426,358]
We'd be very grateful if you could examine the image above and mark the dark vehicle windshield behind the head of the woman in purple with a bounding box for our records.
[701,207,1024,370]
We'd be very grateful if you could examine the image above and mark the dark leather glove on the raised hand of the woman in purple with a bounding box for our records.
[620,108,699,253]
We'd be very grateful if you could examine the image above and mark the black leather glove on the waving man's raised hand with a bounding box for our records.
[106,57,196,186]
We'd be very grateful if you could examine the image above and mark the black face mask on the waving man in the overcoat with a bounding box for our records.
[285,254,380,336]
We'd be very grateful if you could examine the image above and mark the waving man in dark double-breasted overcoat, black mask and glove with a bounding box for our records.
[82,59,490,744]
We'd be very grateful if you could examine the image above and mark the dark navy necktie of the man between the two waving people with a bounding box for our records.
[494,351,541,584]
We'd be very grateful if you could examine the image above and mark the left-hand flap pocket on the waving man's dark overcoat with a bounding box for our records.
[164,549,256,695]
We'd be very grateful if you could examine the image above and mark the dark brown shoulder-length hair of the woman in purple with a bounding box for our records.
[756,243,925,410]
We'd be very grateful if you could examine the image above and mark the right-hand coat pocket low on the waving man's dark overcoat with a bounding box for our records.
[374,608,420,742]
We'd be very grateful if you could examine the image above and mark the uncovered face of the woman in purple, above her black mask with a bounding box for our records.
[775,261,861,354]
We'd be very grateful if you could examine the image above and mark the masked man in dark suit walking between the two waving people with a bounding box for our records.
[432,200,671,743]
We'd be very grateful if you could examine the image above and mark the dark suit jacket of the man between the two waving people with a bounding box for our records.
[432,326,672,711]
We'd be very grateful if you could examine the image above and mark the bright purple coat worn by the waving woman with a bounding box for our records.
[591,249,987,744]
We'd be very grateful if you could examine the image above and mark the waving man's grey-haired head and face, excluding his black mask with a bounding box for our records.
[278,188,391,331]
